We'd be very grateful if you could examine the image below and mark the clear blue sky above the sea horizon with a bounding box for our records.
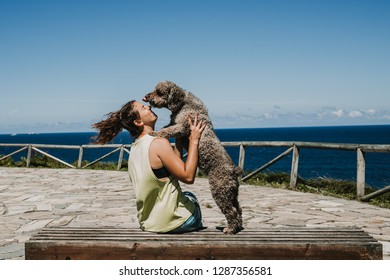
[0,0,390,134]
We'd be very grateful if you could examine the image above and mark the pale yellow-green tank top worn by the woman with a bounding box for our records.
[128,135,195,233]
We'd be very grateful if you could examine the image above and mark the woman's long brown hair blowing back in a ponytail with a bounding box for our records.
[92,100,142,144]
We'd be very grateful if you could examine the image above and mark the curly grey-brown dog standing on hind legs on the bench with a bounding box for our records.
[143,81,243,234]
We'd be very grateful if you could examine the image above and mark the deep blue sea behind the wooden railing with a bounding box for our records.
[0,125,390,189]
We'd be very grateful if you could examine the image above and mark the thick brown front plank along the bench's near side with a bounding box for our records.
[26,241,381,260]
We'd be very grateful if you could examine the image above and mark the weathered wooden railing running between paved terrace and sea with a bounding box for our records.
[0,141,390,201]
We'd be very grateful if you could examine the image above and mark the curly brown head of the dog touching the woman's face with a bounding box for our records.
[142,81,185,112]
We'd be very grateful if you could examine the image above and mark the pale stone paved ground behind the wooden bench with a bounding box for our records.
[0,167,390,259]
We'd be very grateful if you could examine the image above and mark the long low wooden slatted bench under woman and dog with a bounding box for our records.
[25,227,382,260]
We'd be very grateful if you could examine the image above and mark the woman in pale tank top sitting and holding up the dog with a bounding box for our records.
[92,100,205,233]
